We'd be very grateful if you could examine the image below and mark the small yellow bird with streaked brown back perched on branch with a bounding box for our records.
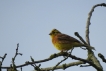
[49,29,95,51]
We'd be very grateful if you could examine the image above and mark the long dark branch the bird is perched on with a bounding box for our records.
[1,52,96,69]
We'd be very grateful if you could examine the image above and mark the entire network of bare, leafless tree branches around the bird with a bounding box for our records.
[0,3,106,71]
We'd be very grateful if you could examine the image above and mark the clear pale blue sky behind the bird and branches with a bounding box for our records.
[0,0,106,71]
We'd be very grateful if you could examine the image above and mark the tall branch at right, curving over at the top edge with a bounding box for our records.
[85,3,106,71]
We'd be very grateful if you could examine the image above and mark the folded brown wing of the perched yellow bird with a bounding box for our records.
[57,34,80,44]
